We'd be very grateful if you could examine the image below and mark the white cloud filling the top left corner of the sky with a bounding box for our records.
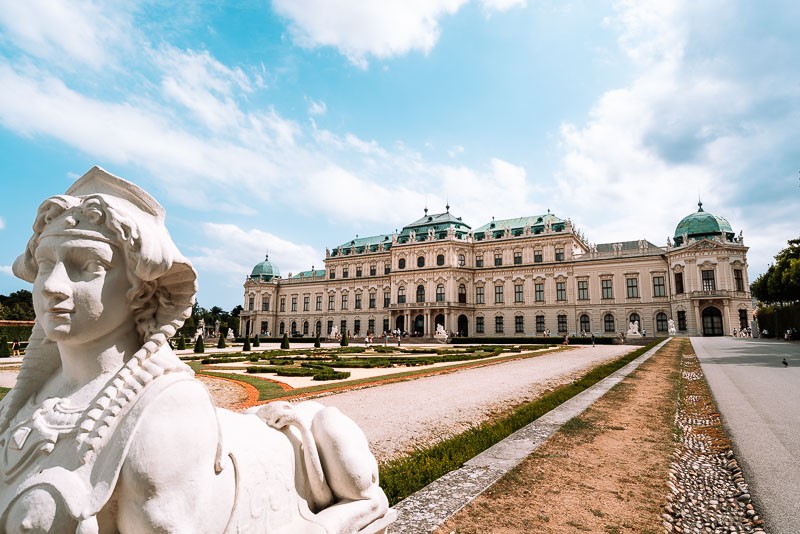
[0,0,130,69]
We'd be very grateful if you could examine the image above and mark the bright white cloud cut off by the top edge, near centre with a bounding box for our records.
[272,0,466,68]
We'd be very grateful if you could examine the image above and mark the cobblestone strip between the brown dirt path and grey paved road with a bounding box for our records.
[662,354,764,533]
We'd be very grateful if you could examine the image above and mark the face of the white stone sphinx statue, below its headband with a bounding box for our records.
[33,235,134,345]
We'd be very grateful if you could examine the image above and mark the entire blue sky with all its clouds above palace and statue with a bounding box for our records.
[0,0,800,309]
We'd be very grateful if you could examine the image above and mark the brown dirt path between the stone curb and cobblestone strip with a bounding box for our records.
[437,340,688,534]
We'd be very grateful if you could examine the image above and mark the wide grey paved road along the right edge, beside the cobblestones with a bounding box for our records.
[692,338,800,534]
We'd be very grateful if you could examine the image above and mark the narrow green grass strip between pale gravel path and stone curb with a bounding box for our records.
[380,340,663,505]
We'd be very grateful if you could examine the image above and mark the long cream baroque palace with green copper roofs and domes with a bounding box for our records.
[240,203,752,337]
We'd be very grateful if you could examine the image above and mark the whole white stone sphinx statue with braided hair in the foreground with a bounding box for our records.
[0,167,394,534]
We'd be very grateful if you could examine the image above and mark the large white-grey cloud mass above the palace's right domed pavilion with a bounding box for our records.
[553,0,800,271]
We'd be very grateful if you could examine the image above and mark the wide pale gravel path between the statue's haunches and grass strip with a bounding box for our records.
[317,345,637,460]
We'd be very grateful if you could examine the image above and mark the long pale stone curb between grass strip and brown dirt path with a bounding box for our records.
[391,338,670,534]
